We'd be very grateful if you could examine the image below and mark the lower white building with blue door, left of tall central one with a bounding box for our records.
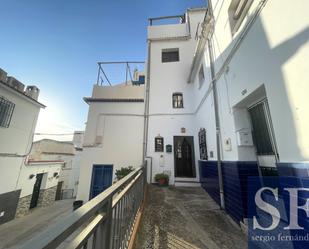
[76,81,144,202]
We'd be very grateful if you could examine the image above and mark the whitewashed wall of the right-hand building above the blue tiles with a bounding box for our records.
[194,0,309,162]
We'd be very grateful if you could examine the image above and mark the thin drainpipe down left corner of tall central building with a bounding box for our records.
[143,40,152,163]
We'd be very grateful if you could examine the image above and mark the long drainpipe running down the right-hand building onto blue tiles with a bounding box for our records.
[207,0,225,209]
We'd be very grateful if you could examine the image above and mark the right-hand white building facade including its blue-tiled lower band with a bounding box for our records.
[189,0,309,222]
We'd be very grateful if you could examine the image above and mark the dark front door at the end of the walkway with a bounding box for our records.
[174,136,196,177]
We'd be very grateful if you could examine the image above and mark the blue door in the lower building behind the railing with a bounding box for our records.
[90,164,113,199]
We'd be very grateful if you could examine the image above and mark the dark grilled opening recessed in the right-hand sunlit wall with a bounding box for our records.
[249,103,274,155]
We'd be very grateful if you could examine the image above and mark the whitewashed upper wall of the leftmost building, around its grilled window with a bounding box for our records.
[0,85,40,194]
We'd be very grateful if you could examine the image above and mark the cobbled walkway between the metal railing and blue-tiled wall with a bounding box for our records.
[135,186,247,249]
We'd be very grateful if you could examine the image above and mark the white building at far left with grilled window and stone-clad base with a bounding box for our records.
[0,70,60,224]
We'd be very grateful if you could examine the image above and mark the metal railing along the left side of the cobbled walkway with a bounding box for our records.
[22,166,147,249]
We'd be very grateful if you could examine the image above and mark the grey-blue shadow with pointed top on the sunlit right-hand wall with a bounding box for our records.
[215,14,309,162]
